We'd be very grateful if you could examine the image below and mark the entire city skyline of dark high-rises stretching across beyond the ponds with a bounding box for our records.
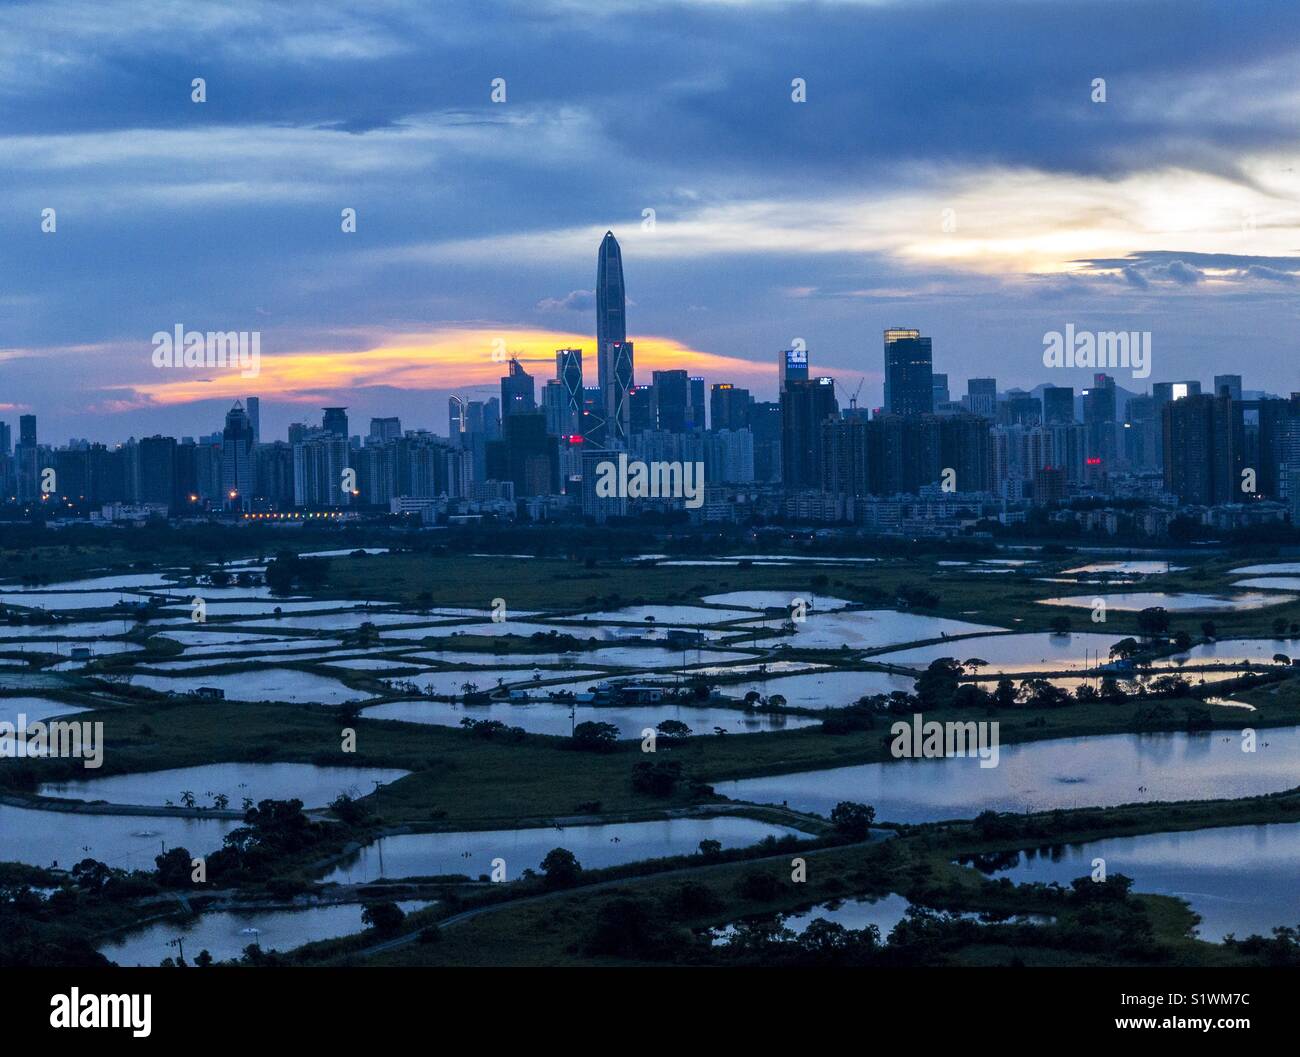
[0,226,1300,536]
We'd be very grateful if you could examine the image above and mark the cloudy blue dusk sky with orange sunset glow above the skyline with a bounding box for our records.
[0,0,1300,443]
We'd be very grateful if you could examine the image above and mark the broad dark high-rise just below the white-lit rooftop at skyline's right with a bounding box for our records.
[1162,395,1245,506]
